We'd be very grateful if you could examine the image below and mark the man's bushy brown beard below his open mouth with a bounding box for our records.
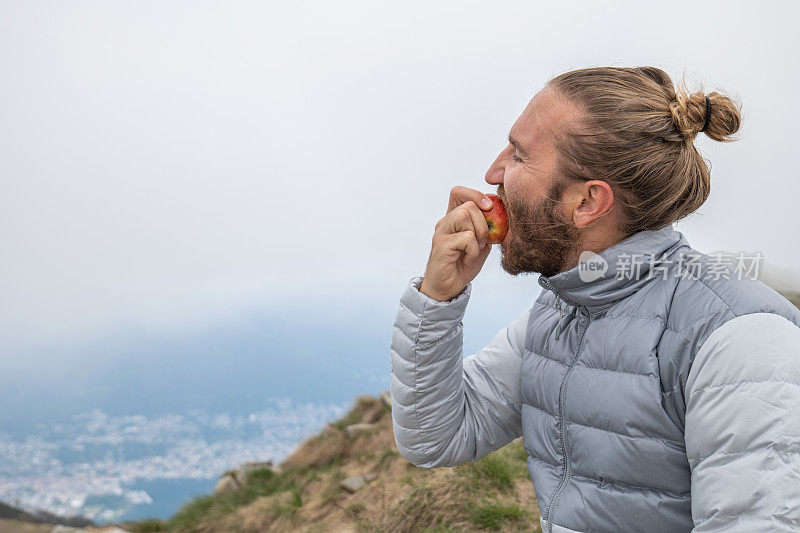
[497,183,580,277]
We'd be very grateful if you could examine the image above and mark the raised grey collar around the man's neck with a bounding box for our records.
[539,224,689,312]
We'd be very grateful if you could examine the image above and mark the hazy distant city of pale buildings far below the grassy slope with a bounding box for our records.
[0,397,352,523]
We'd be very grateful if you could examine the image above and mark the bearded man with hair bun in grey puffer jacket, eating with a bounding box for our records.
[391,67,800,532]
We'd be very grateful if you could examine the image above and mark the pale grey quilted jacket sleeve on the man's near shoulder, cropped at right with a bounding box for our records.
[685,313,800,533]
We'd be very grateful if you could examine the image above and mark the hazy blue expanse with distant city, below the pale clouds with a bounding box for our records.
[0,308,393,524]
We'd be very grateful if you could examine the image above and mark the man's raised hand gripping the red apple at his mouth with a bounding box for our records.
[419,186,492,302]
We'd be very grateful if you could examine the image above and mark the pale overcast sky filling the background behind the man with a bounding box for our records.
[0,0,800,364]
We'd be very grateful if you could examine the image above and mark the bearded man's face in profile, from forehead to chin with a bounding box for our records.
[486,88,580,276]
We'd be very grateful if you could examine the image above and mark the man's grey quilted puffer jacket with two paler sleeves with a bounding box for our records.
[390,222,800,532]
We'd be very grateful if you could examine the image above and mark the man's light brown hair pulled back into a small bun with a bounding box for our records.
[547,67,741,237]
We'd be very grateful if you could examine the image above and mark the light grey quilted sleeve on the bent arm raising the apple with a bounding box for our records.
[390,277,530,468]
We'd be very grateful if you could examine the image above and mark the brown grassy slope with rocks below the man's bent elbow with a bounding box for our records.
[119,392,539,533]
